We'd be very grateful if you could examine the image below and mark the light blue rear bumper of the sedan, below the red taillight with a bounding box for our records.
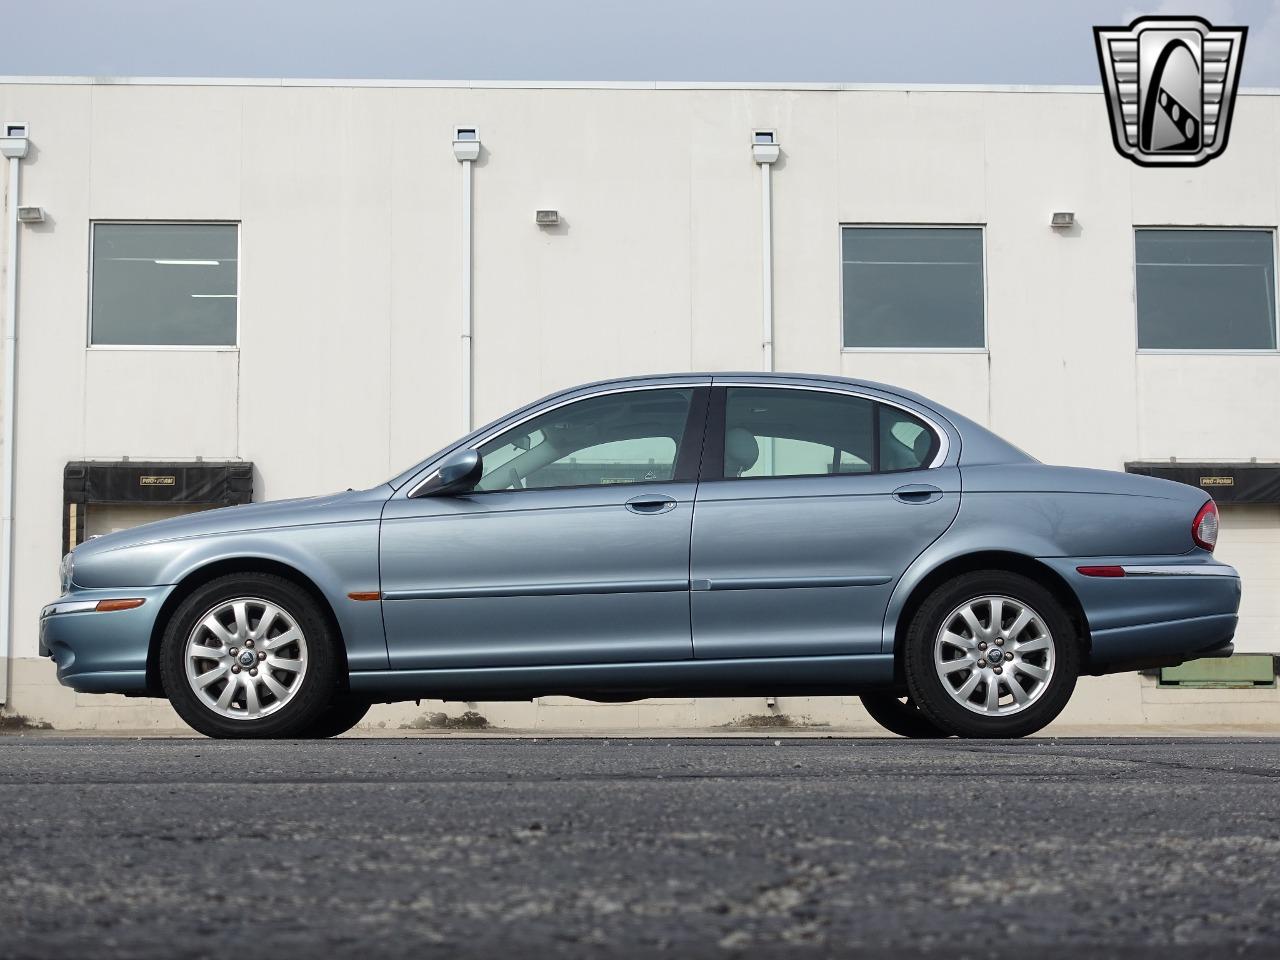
[1042,553,1240,673]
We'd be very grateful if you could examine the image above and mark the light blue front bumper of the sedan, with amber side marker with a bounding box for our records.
[40,586,173,694]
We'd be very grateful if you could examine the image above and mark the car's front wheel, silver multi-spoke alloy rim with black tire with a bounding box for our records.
[160,573,338,739]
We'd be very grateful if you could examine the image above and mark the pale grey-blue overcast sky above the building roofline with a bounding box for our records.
[0,0,1280,87]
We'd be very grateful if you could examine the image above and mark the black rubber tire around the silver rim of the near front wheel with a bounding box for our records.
[160,573,339,739]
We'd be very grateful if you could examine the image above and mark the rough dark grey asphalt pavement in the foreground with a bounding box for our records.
[0,736,1280,960]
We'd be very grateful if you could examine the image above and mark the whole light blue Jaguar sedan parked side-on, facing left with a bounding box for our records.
[40,374,1240,737]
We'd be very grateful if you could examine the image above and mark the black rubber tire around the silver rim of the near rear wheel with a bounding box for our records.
[904,570,1080,737]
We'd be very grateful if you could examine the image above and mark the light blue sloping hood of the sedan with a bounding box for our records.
[76,484,392,559]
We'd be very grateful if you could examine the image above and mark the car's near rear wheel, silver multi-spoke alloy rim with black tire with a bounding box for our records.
[904,571,1080,737]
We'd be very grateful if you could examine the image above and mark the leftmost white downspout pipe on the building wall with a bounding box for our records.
[0,123,28,704]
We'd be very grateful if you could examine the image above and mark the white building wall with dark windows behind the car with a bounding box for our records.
[0,81,1280,722]
